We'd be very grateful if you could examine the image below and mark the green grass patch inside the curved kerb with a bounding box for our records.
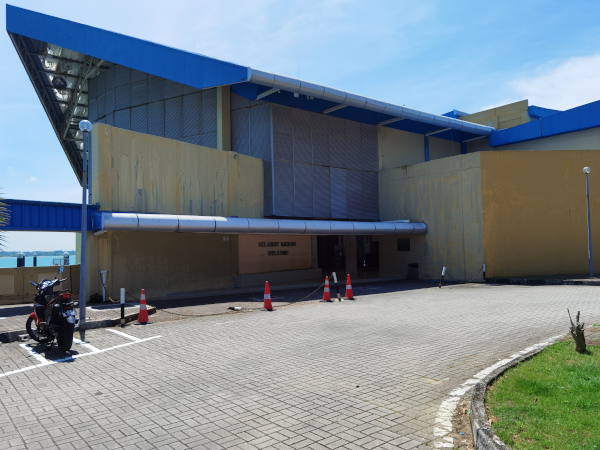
[486,342,600,450]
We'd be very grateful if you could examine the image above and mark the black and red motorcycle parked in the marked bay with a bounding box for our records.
[25,278,77,352]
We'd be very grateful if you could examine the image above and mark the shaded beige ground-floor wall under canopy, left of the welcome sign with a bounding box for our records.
[88,231,237,299]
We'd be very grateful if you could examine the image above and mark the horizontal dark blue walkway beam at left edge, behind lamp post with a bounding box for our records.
[0,199,98,232]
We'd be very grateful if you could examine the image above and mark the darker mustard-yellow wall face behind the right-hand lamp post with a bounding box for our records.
[481,150,600,277]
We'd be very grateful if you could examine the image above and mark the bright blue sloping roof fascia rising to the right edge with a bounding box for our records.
[489,100,600,147]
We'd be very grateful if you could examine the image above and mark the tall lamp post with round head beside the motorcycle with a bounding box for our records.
[79,120,93,341]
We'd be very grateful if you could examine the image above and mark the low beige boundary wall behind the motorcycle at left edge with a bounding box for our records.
[0,266,79,305]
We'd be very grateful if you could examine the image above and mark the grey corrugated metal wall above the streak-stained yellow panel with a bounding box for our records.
[88,65,217,148]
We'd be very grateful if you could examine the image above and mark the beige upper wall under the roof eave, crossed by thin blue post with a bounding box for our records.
[377,127,460,169]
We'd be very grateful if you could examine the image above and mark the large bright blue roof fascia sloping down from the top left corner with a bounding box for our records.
[6,5,248,89]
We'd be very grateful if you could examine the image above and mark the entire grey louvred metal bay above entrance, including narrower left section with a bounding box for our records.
[231,94,379,220]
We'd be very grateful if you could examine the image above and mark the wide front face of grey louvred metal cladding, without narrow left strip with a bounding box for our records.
[272,105,379,220]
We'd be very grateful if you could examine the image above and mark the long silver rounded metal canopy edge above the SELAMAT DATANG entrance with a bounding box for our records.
[98,212,427,235]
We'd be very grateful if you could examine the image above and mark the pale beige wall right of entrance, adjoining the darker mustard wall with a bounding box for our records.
[379,153,484,281]
